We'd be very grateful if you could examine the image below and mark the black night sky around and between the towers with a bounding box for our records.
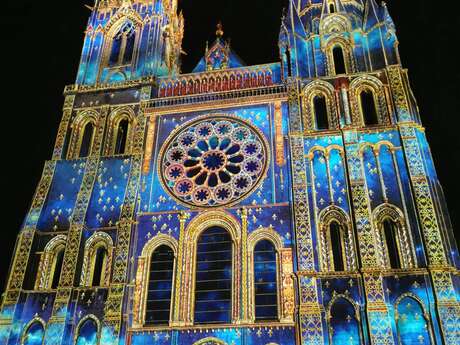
[0,0,460,290]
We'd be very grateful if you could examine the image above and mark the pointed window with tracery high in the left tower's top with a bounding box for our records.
[109,21,136,67]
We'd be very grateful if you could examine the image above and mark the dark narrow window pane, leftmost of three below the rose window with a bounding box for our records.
[145,245,174,325]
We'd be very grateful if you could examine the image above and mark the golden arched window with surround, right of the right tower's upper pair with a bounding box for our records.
[350,75,390,126]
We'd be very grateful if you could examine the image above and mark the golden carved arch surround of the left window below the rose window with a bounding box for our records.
[133,234,179,327]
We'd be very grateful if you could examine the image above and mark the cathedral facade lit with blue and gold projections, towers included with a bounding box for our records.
[0,0,460,345]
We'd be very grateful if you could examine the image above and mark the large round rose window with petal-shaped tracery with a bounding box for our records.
[159,115,268,207]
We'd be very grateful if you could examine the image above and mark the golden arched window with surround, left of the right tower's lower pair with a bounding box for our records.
[318,205,358,272]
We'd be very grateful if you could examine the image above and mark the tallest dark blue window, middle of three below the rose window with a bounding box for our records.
[194,226,233,324]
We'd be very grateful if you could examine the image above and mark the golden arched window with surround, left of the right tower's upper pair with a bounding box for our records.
[303,80,339,130]
